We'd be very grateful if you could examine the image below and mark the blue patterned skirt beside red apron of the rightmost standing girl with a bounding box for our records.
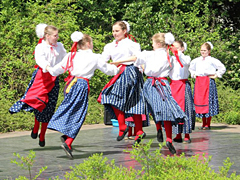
[194,79,219,118]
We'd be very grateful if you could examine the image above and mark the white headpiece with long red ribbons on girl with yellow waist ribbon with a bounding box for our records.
[62,31,83,79]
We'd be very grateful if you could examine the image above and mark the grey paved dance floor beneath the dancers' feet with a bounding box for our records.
[0,123,240,180]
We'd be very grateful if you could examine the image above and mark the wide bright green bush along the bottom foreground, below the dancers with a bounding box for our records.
[55,141,240,180]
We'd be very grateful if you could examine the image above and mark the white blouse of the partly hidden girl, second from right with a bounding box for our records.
[169,51,191,80]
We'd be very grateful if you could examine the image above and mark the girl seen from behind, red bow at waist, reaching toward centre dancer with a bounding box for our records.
[111,33,187,154]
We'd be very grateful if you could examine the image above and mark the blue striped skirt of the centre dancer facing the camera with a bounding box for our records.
[101,65,146,119]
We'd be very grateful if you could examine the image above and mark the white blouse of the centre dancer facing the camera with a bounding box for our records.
[102,38,141,65]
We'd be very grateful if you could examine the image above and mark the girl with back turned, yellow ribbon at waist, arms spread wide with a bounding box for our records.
[47,31,119,158]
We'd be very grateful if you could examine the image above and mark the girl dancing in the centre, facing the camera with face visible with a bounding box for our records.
[98,21,146,143]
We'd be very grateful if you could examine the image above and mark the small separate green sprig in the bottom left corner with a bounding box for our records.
[11,150,47,180]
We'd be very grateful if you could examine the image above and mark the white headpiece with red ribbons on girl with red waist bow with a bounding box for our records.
[165,32,183,67]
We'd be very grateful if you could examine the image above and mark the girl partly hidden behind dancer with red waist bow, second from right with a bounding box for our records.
[169,41,195,143]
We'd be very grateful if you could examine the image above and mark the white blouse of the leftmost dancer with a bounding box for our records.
[34,40,67,73]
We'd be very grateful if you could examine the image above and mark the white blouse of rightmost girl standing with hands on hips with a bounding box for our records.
[189,56,226,78]
